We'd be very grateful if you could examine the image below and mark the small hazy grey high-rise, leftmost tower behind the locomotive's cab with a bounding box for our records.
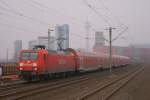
[14,40,22,60]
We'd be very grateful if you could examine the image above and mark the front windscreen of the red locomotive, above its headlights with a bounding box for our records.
[21,52,38,60]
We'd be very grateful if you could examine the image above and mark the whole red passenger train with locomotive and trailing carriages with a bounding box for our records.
[17,45,130,81]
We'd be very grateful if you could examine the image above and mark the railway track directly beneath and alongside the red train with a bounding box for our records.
[0,70,102,97]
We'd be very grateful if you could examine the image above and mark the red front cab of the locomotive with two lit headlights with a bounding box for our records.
[18,46,48,80]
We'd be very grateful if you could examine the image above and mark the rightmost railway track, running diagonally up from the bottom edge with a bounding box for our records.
[77,67,144,100]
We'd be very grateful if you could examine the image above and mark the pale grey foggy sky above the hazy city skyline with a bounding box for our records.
[0,0,150,59]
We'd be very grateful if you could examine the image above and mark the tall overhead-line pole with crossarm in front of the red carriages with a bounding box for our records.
[106,27,116,73]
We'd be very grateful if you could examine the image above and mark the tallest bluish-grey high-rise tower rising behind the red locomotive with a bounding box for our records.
[55,24,69,50]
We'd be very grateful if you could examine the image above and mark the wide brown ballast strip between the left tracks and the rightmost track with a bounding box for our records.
[17,66,140,100]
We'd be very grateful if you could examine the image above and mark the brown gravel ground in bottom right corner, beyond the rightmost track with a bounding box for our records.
[109,65,150,100]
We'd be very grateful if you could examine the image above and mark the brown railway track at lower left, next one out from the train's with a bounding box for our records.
[0,73,92,100]
